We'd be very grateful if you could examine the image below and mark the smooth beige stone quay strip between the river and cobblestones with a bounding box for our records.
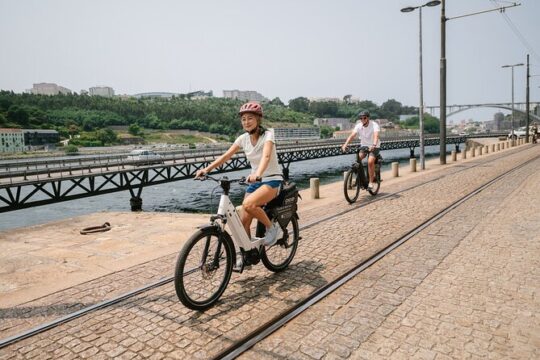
[0,138,508,307]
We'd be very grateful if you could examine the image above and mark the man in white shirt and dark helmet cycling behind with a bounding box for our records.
[341,111,381,188]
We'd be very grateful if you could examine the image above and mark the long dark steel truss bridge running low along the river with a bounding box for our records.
[0,135,476,213]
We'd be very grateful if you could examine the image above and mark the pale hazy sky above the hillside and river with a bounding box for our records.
[0,0,540,120]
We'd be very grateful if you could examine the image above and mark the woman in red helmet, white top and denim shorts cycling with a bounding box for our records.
[195,102,282,246]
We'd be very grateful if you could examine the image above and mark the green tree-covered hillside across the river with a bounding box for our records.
[0,91,422,146]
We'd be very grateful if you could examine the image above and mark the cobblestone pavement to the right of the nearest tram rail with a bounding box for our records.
[245,147,540,359]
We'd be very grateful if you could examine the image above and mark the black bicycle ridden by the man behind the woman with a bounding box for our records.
[343,146,382,204]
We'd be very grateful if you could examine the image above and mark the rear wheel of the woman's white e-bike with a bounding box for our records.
[261,214,300,272]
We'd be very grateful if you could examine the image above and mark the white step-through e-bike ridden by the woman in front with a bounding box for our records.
[174,175,300,311]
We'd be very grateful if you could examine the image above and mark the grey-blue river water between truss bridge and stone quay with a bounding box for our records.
[0,145,456,231]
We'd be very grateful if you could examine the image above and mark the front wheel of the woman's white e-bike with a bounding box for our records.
[174,228,234,311]
